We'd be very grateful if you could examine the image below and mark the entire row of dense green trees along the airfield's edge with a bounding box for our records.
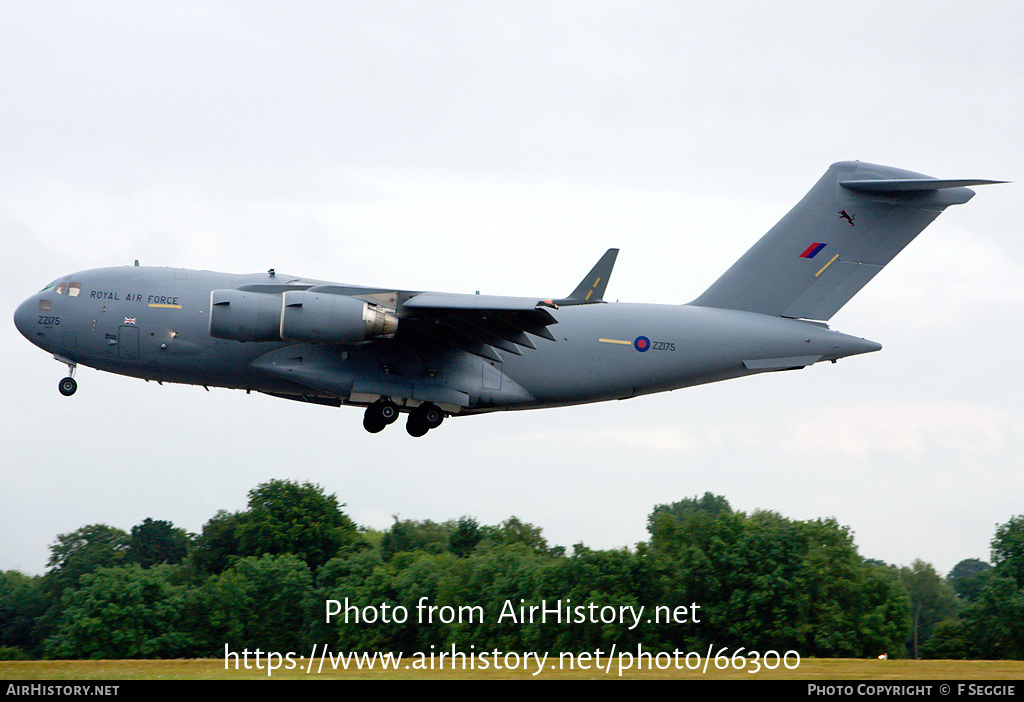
[0,480,1024,659]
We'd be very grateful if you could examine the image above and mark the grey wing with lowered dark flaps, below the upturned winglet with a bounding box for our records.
[399,293,558,362]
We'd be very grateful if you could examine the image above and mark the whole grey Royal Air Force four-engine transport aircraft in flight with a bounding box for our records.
[14,162,1001,436]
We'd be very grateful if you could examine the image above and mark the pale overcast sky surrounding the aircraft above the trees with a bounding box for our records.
[0,0,1024,573]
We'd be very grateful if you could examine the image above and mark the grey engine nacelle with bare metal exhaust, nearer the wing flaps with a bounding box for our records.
[281,291,398,344]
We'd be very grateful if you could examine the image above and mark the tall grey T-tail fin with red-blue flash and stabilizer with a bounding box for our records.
[690,161,1001,320]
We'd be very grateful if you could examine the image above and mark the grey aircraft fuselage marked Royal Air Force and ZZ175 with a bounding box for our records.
[15,266,881,423]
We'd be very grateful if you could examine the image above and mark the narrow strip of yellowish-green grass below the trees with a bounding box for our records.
[0,658,1024,681]
